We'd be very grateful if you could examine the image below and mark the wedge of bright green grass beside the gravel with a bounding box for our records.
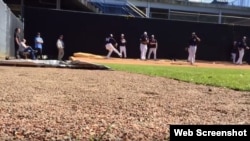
[104,64,250,91]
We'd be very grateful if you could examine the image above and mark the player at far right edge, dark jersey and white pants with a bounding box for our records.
[236,36,249,65]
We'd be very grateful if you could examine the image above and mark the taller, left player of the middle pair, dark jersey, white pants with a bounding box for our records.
[140,32,149,60]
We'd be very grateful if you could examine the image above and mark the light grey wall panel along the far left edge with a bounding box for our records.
[0,1,23,57]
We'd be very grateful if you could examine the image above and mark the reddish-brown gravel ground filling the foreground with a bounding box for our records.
[0,66,250,141]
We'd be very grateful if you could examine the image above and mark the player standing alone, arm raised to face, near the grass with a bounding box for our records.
[188,32,201,65]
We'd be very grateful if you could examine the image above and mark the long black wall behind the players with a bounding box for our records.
[24,7,250,61]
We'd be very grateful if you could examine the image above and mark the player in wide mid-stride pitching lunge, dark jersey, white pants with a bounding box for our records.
[105,34,122,58]
